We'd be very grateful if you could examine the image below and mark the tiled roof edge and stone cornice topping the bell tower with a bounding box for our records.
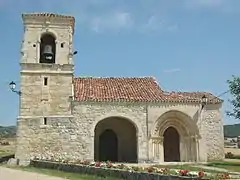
[22,12,75,32]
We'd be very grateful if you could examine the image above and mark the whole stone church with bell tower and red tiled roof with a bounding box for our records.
[15,13,224,164]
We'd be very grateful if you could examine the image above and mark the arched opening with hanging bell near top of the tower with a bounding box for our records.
[39,33,56,64]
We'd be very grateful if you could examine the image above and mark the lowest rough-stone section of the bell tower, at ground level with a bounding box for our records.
[16,117,88,160]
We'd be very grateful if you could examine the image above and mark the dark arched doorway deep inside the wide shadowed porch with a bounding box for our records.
[99,129,118,162]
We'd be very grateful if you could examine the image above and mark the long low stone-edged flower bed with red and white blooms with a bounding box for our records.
[31,159,204,180]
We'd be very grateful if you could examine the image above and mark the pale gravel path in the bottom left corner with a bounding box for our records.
[0,167,66,180]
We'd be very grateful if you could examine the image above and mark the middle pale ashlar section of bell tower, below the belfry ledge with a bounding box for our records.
[20,71,72,117]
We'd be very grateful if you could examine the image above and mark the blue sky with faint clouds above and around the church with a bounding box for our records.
[0,0,240,125]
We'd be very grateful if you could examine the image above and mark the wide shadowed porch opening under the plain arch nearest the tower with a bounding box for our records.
[94,117,138,163]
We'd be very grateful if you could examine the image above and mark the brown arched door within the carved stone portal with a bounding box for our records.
[163,127,180,162]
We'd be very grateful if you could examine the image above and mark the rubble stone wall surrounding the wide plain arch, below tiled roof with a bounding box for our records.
[74,103,147,161]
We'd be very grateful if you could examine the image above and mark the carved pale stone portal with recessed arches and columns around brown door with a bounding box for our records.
[150,110,200,162]
